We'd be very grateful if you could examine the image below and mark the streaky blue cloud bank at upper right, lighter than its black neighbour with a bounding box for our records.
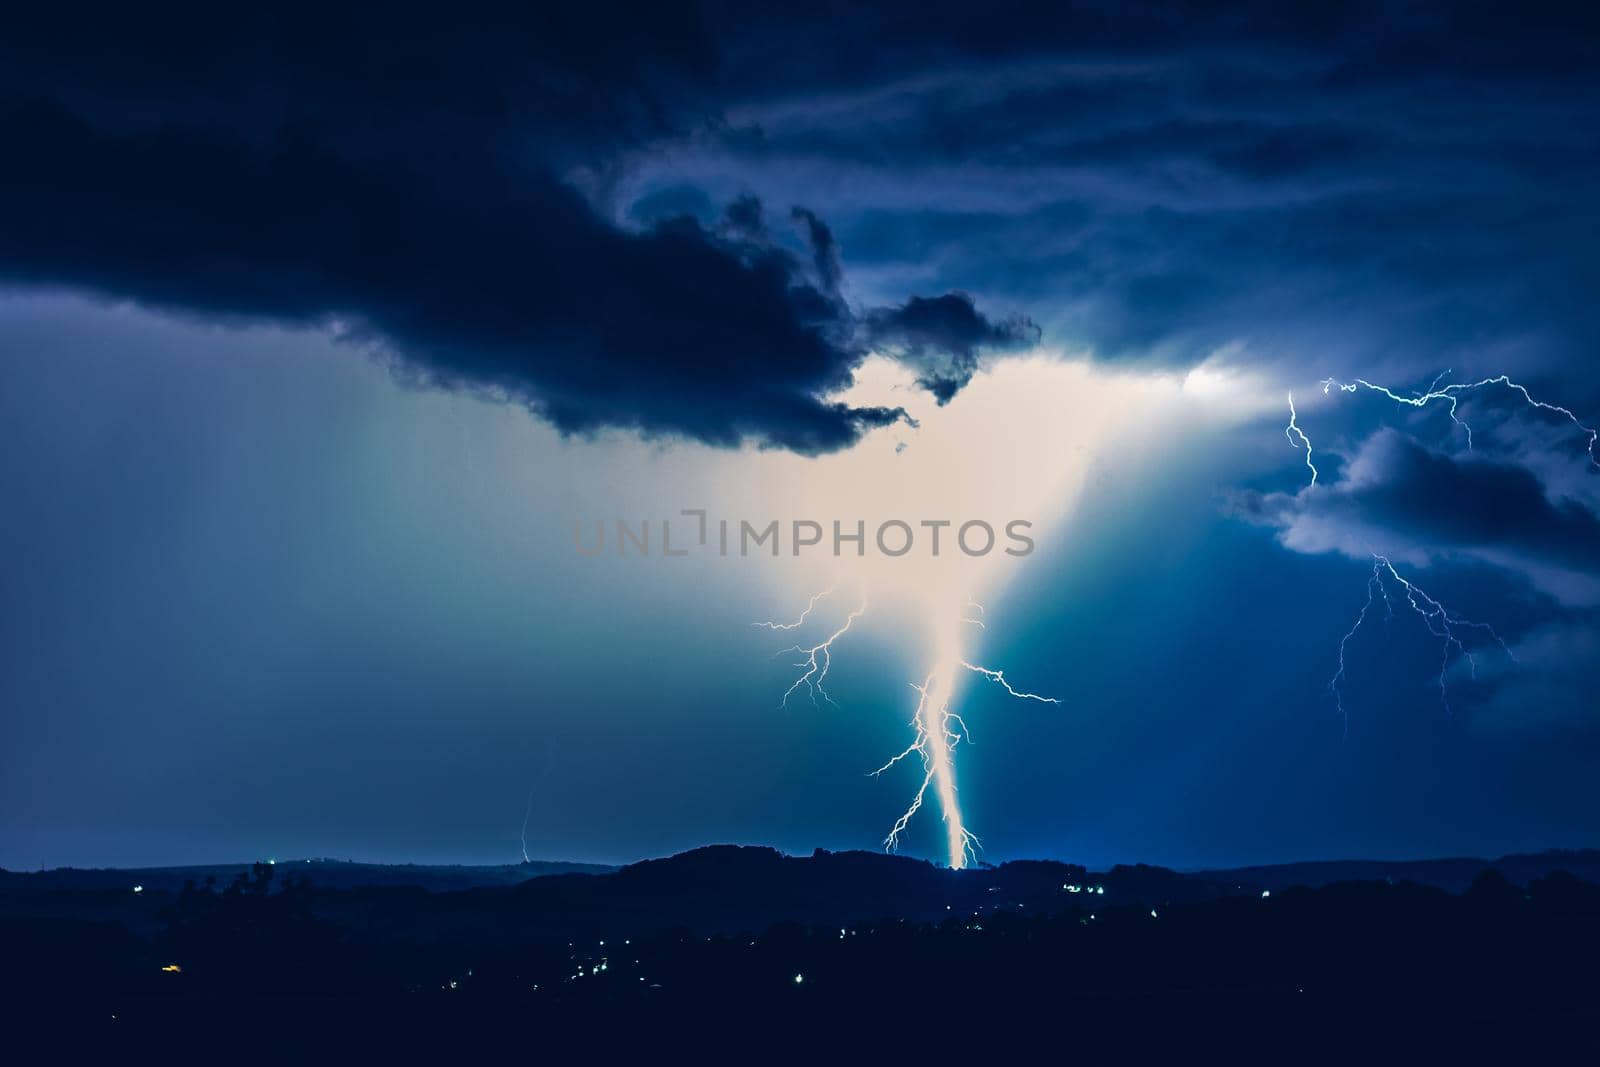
[627,3,1600,403]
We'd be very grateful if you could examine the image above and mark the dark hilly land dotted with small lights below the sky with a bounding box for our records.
[9,848,1600,1064]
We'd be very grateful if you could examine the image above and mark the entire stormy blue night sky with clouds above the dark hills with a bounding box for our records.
[0,0,1600,869]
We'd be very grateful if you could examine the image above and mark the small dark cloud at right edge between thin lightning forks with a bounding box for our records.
[1229,429,1600,601]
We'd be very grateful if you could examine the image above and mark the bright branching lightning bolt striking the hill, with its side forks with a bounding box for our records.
[768,593,1061,869]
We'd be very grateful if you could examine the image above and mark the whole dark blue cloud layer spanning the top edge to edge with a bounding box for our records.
[0,2,1600,451]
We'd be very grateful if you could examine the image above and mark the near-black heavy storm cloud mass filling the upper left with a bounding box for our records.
[0,5,1043,453]
